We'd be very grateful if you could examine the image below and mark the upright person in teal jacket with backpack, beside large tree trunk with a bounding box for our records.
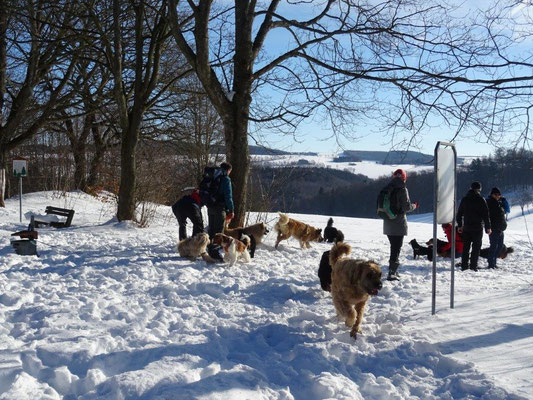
[207,162,234,239]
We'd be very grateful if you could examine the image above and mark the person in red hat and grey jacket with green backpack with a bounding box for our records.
[383,169,418,281]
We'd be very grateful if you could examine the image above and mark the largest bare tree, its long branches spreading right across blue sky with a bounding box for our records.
[169,0,532,224]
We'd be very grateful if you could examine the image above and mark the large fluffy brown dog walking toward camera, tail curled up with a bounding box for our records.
[329,243,382,339]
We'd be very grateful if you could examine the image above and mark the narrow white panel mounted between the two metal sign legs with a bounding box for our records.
[437,146,455,224]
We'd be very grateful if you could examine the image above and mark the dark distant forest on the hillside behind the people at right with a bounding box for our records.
[250,150,533,218]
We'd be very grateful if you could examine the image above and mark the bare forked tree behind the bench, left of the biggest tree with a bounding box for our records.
[85,0,195,221]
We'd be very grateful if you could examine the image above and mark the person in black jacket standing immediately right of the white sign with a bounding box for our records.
[456,182,491,271]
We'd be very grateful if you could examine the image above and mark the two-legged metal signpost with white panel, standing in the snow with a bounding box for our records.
[431,142,457,314]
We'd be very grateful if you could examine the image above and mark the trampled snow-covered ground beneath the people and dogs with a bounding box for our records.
[0,192,533,400]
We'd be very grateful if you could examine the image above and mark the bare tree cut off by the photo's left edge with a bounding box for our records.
[0,0,77,207]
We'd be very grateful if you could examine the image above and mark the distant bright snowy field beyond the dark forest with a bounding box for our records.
[252,153,433,179]
